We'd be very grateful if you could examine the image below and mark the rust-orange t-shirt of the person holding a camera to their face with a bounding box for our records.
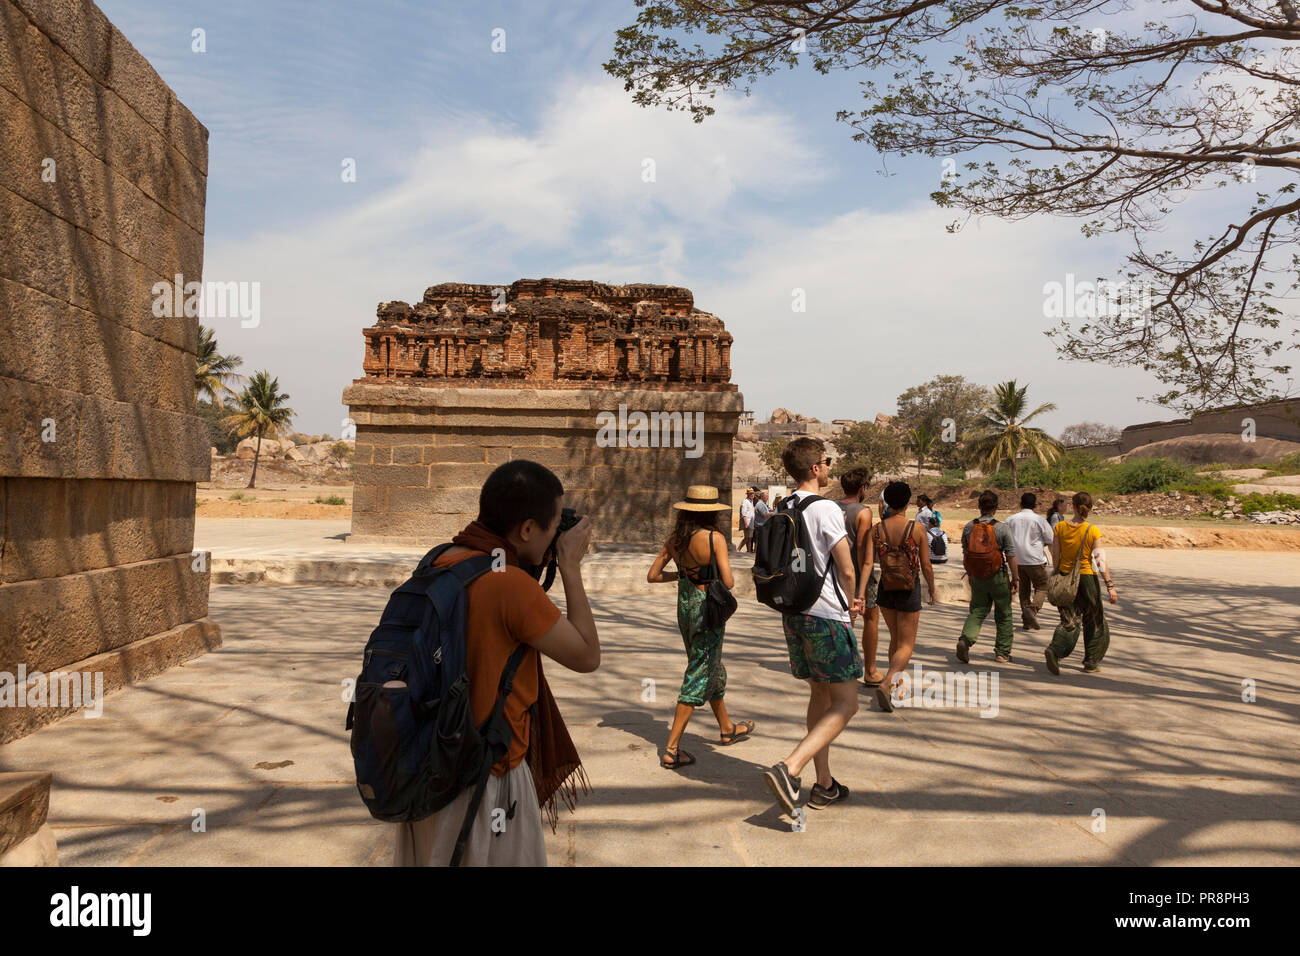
[434,551,560,777]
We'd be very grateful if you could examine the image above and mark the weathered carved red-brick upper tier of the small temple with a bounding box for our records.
[356,278,736,392]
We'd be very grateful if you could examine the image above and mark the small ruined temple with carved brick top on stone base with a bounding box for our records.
[343,280,744,550]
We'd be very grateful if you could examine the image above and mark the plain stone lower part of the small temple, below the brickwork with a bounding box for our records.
[343,382,744,550]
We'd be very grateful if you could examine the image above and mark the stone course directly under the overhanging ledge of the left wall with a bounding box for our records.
[0,479,195,584]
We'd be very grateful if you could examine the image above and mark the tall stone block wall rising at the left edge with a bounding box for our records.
[0,0,220,741]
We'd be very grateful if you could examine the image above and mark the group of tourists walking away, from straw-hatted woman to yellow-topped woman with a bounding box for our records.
[647,437,1118,813]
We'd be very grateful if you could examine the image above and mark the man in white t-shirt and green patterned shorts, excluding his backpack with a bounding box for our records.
[763,438,865,814]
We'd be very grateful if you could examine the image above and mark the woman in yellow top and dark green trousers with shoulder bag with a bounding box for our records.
[1044,492,1119,675]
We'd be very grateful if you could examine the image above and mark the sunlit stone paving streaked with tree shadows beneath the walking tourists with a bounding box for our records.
[0,549,1300,865]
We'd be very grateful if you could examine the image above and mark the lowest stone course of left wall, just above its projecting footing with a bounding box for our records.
[0,554,209,674]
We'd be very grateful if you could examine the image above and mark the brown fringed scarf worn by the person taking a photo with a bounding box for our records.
[451,522,592,832]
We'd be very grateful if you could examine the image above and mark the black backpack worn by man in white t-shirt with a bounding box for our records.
[751,494,849,614]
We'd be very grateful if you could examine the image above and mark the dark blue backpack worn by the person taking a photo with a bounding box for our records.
[345,544,527,866]
